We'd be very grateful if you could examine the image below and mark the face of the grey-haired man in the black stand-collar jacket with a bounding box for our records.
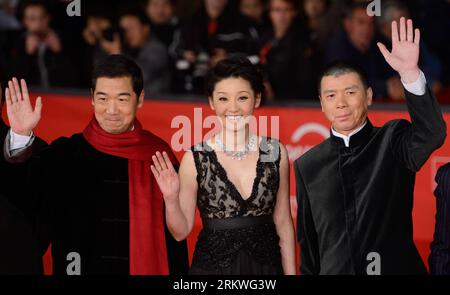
[320,72,372,135]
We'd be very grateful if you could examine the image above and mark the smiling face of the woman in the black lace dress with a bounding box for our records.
[209,78,261,132]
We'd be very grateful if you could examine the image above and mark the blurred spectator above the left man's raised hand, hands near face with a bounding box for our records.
[12,1,78,87]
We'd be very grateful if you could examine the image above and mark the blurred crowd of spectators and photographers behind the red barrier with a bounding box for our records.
[0,0,450,101]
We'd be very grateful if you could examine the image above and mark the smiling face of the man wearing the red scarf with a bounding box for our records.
[92,77,144,134]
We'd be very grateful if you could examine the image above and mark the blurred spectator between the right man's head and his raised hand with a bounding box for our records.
[324,3,398,99]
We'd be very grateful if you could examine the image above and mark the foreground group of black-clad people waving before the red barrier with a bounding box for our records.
[0,13,450,275]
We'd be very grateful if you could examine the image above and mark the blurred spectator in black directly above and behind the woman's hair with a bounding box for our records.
[177,0,258,94]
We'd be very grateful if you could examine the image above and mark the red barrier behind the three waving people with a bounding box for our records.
[2,95,450,274]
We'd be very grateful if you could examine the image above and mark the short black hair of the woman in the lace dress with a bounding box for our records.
[206,55,264,96]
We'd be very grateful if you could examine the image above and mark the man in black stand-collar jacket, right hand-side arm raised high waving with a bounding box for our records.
[294,18,446,274]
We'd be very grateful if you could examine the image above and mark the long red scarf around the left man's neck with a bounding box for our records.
[83,118,178,275]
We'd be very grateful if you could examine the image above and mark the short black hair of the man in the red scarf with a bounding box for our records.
[91,54,144,96]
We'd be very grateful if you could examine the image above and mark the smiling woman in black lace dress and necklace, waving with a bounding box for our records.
[151,57,296,275]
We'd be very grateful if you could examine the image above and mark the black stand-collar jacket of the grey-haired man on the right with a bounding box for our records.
[294,86,446,274]
